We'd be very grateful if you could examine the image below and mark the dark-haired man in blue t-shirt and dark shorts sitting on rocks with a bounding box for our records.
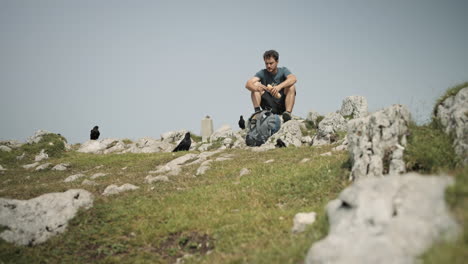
[245,50,297,122]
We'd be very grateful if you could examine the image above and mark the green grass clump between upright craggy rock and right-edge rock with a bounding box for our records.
[404,123,460,173]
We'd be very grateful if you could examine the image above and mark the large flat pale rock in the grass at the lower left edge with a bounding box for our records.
[0,189,93,246]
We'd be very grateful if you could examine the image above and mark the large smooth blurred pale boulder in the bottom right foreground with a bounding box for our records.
[305,174,459,264]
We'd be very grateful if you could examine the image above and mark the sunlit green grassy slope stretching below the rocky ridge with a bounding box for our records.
[0,144,348,263]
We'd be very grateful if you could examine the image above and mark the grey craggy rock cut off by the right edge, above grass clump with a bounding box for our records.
[436,87,468,164]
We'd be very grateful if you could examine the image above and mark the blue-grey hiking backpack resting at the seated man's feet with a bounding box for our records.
[245,110,281,147]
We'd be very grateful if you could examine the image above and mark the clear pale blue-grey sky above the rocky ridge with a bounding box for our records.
[0,0,468,143]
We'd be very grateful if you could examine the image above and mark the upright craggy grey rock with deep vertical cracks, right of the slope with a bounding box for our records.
[348,105,411,179]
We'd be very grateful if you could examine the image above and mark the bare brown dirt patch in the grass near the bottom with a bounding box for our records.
[155,232,214,263]
